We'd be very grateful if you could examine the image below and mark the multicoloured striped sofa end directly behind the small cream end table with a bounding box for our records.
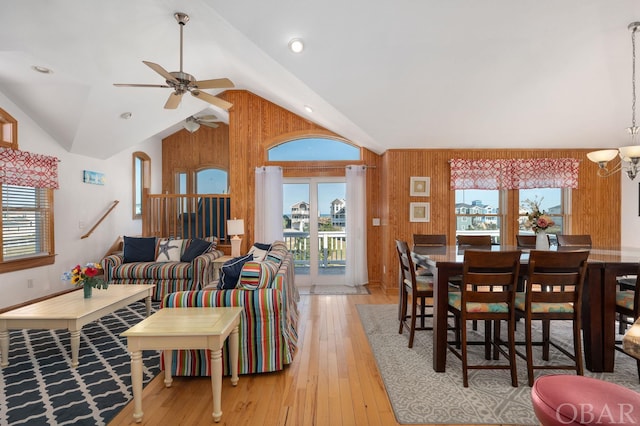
[160,241,300,376]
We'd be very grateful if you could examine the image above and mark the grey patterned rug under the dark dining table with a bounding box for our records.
[357,305,640,425]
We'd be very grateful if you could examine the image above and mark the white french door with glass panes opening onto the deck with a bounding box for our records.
[283,177,347,285]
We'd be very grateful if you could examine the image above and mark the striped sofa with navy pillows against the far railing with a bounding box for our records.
[101,237,223,302]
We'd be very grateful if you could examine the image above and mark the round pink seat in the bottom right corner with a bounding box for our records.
[531,374,640,426]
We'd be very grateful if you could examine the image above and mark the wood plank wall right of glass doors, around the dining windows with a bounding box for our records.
[380,151,621,293]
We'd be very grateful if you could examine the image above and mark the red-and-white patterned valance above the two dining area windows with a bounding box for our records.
[450,158,580,189]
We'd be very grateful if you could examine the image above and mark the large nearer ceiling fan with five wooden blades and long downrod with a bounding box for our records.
[114,12,234,110]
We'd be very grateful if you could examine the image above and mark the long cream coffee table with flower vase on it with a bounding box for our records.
[0,284,155,368]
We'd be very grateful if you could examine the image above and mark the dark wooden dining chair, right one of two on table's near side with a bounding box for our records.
[516,250,589,386]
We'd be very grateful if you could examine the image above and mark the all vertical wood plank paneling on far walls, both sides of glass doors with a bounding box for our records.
[162,90,621,293]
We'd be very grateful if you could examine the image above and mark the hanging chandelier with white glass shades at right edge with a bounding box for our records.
[587,22,640,180]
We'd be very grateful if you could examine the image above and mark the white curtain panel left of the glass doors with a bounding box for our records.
[254,166,284,243]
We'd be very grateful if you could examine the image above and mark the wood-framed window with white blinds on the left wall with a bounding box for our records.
[0,184,54,272]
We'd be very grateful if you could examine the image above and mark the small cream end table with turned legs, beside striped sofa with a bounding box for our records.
[121,307,242,423]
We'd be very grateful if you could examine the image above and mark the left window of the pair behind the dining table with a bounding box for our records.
[455,189,502,244]
